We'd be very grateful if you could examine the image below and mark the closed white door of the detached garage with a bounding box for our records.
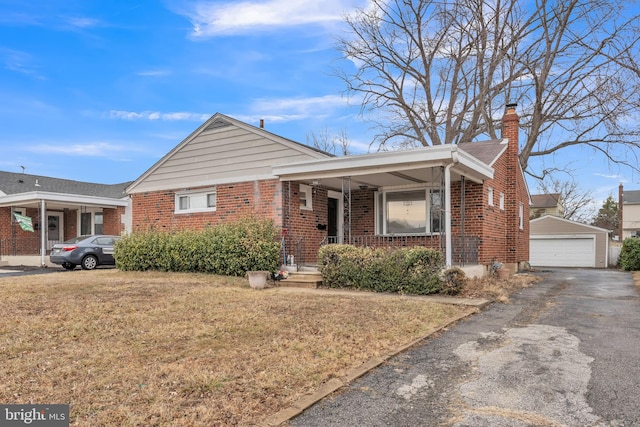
[529,236,596,267]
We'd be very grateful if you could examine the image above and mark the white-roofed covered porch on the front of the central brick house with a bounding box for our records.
[273,141,498,266]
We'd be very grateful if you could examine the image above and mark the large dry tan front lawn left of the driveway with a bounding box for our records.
[0,269,471,426]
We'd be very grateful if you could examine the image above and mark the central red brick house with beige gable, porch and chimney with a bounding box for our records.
[126,105,530,271]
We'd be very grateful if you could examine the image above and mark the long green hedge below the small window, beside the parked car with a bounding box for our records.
[114,218,281,276]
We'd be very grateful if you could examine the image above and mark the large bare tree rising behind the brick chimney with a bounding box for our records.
[337,0,640,179]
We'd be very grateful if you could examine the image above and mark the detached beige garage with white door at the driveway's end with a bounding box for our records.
[529,215,609,268]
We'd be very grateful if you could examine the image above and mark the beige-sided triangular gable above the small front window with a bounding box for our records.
[127,114,330,194]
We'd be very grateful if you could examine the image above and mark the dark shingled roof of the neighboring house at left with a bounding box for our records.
[0,171,130,199]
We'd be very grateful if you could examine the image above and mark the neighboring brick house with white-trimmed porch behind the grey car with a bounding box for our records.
[0,172,131,266]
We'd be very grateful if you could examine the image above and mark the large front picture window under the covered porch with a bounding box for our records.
[376,188,444,235]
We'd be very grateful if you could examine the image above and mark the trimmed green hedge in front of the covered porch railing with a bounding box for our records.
[318,245,444,295]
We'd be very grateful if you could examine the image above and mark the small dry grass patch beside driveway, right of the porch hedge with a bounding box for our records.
[460,273,542,303]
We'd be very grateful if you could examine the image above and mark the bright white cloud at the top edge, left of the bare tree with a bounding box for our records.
[181,0,355,38]
